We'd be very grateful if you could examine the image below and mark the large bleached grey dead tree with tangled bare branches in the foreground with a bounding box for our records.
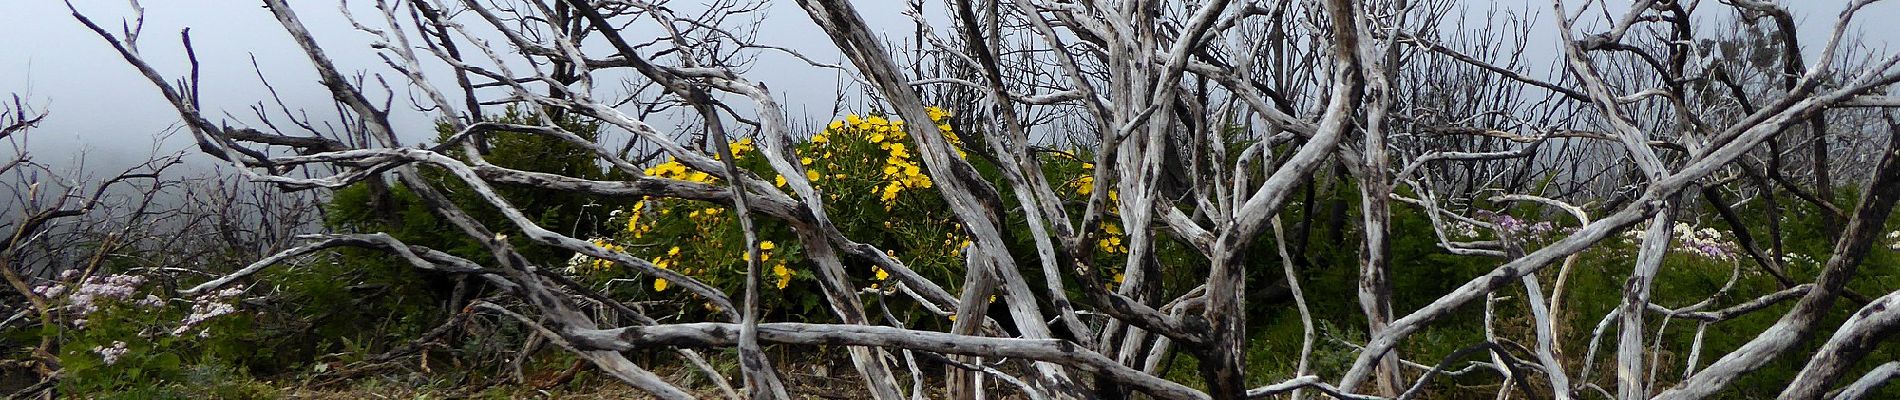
[74,0,1900,400]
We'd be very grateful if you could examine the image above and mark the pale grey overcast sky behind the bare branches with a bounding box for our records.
[0,0,1900,173]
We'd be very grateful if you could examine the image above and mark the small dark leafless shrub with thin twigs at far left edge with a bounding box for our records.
[0,95,184,396]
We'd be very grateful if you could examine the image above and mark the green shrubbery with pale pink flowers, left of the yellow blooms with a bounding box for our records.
[38,108,630,398]
